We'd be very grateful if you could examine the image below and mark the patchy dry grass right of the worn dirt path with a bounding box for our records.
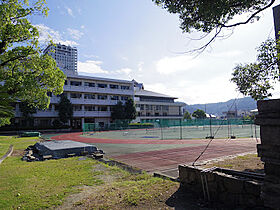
[84,173,179,209]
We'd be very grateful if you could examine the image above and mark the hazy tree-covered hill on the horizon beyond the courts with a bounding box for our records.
[184,97,257,116]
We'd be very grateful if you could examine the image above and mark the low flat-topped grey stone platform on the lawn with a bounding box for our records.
[22,140,104,161]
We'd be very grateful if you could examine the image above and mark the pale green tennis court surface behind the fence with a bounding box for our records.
[83,124,260,140]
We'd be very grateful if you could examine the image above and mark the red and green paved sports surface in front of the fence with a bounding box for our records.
[52,133,257,177]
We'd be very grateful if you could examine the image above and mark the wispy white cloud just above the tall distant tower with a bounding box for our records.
[35,24,78,46]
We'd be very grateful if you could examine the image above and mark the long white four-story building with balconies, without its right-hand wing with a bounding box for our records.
[15,75,134,128]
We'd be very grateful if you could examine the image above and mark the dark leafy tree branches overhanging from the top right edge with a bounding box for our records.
[152,0,275,51]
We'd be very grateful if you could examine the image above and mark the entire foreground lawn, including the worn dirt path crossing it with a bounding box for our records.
[0,137,179,209]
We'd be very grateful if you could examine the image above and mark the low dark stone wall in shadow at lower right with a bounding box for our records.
[179,165,263,208]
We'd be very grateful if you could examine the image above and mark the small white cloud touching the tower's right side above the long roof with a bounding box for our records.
[78,60,109,74]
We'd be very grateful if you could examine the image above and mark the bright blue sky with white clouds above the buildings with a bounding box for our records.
[30,0,280,104]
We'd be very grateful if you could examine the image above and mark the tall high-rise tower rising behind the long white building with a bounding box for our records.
[44,44,78,75]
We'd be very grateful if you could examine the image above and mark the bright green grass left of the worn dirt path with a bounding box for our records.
[0,137,104,209]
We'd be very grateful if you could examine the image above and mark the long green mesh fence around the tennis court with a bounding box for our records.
[83,119,260,140]
